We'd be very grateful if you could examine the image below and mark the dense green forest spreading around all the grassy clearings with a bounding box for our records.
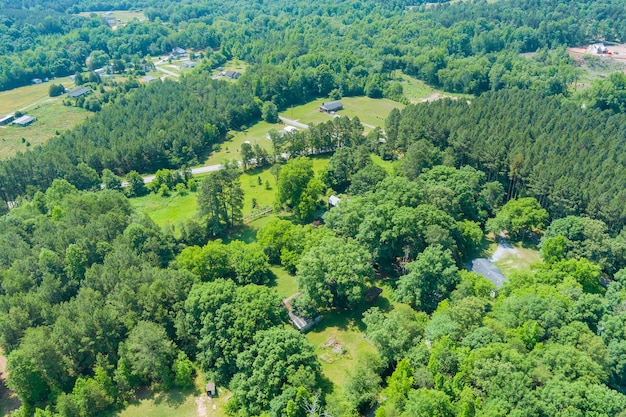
[0,0,626,417]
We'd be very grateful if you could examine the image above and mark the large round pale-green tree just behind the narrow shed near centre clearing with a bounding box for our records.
[296,237,374,309]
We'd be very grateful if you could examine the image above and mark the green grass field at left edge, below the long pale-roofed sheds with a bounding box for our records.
[0,100,90,160]
